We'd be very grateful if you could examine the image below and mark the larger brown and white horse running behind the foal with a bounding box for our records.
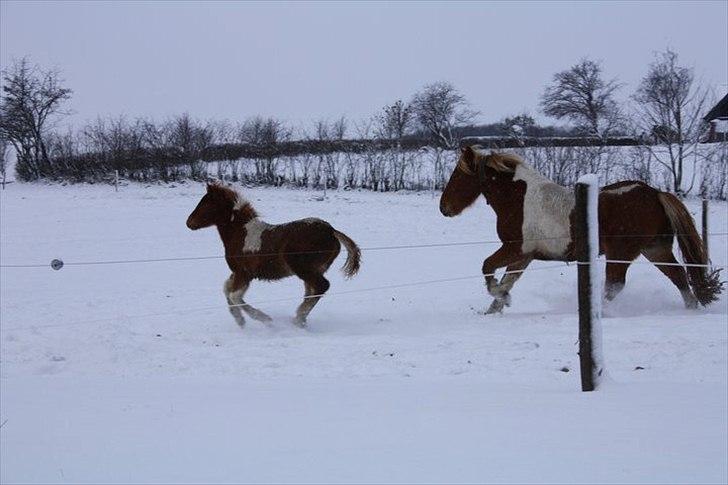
[440,145,723,313]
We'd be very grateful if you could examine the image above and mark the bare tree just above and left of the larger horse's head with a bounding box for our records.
[411,81,478,150]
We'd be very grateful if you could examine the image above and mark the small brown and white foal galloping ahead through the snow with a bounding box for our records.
[187,183,361,327]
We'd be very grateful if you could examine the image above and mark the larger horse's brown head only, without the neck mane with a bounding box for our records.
[440,146,485,217]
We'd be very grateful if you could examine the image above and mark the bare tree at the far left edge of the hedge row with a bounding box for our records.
[0,58,72,180]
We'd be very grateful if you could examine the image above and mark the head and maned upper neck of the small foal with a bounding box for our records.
[187,183,257,231]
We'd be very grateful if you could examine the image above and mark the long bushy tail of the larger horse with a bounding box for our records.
[657,192,723,306]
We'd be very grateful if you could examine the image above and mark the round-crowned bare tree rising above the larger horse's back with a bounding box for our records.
[541,59,622,137]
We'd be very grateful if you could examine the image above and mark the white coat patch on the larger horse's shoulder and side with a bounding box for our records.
[513,164,574,258]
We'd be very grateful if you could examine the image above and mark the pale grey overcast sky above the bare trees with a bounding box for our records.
[0,0,728,130]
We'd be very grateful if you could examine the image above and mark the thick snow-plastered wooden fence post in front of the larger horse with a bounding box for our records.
[574,174,604,391]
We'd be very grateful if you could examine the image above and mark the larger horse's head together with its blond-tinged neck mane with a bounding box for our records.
[440,146,523,217]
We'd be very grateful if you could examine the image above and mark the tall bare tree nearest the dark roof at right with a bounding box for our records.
[633,49,710,195]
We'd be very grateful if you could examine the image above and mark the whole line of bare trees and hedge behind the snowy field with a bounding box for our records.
[0,50,723,199]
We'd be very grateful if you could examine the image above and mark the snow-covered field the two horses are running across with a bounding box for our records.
[0,184,728,483]
